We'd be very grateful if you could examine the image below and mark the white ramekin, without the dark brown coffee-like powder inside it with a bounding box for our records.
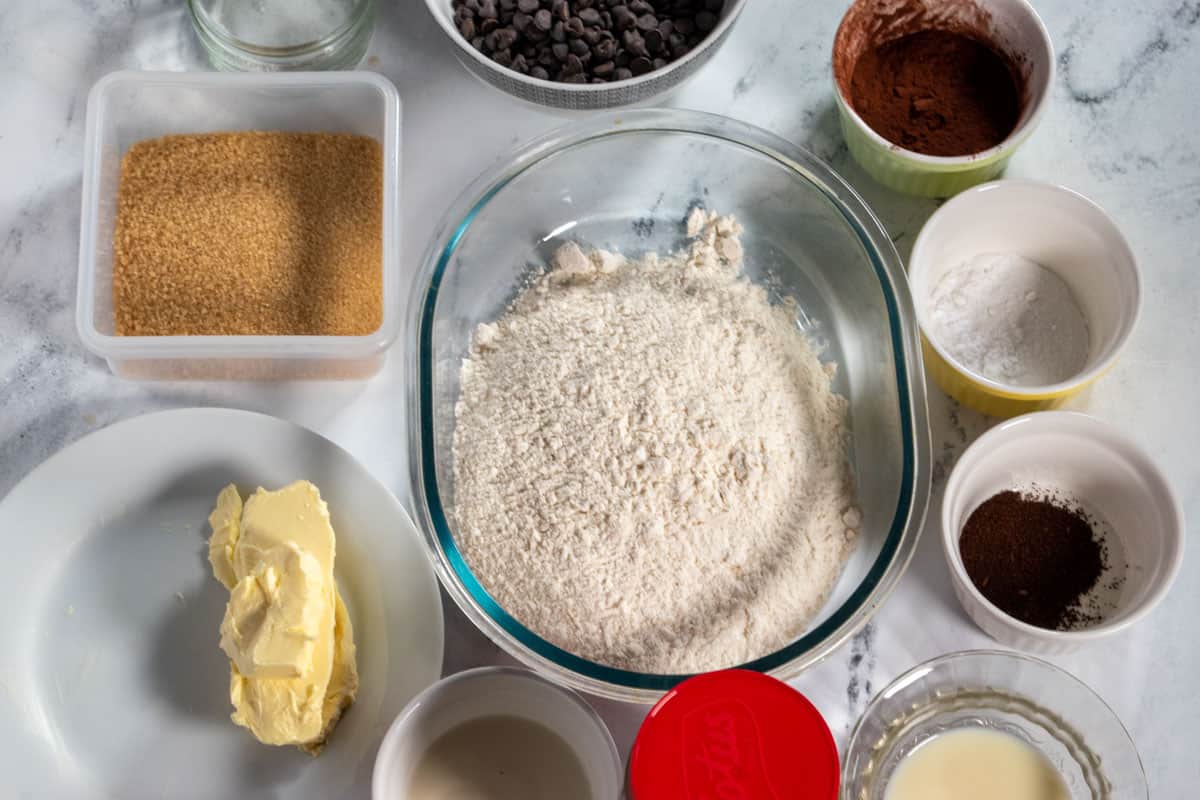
[942,411,1184,654]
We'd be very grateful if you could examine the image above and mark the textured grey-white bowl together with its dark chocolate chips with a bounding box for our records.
[425,0,746,110]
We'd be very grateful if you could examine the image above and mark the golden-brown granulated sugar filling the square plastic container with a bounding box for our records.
[113,132,383,336]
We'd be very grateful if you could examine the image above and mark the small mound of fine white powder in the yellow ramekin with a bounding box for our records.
[929,253,1090,386]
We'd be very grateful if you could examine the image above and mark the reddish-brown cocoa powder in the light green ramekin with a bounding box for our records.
[850,30,1020,156]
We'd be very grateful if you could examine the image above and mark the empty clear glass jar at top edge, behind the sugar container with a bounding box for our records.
[187,0,374,72]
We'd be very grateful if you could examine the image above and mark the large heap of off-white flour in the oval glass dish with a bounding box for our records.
[452,210,860,673]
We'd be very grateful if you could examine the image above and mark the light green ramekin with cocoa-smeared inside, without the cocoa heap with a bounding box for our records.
[833,0,1055,197]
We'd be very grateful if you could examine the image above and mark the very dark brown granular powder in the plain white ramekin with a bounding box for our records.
[959,492,1105,630]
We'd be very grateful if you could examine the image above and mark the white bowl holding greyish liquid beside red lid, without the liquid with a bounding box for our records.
[371,667,623,800]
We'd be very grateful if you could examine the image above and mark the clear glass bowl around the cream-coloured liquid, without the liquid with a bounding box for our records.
[841,650,1150,800]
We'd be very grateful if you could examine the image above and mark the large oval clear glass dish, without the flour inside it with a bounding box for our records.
[408,110,930,703]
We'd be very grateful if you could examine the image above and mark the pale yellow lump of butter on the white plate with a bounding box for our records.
[209,481,358,756]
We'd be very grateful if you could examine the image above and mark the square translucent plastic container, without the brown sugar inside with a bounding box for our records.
[76,72,404,379]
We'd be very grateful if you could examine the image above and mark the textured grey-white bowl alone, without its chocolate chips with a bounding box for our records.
[425,0,746,110]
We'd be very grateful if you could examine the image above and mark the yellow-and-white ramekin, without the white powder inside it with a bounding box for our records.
[908,180,1141,417]
